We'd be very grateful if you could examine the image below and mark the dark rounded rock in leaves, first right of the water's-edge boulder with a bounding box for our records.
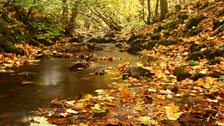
[174,67,191,81]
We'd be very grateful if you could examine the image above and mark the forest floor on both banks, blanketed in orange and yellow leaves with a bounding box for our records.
[0,0,224,126]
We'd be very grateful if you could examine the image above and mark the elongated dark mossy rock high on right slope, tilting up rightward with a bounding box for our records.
[186,16,206,29]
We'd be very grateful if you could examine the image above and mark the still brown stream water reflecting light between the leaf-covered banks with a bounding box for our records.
[0,44,140,126]
